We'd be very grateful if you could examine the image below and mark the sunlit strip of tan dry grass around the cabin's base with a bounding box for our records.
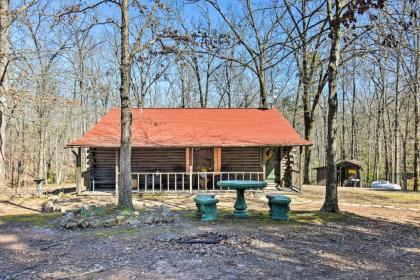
[0,186,420,224]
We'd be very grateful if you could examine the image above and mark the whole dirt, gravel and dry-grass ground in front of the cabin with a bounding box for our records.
[0,186,420,279]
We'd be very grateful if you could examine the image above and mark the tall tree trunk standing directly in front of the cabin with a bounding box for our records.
[118,0,133,209]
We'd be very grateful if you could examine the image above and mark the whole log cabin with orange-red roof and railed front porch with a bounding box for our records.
[67,108,311,193]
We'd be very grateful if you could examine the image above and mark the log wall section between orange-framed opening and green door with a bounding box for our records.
[222,147,262,172]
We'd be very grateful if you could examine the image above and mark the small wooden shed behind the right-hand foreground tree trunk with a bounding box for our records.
[314,159,363,187]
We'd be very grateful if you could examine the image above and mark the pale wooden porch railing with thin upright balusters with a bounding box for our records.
[92,166,266,193]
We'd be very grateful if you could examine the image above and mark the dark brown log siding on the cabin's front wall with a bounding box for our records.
[88,147,262,188]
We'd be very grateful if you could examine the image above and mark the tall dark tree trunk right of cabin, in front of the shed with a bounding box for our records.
[321,0,341,213]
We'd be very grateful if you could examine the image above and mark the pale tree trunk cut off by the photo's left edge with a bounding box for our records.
[0,0,9,189]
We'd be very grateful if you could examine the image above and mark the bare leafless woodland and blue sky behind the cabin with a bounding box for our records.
[0,0,420,206]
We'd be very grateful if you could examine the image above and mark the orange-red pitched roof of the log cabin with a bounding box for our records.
[67,108,311,147]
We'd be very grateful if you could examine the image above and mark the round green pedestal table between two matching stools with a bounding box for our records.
[217,180,267,218]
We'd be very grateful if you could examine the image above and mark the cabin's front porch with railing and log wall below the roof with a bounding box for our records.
[79,147,300,193]
